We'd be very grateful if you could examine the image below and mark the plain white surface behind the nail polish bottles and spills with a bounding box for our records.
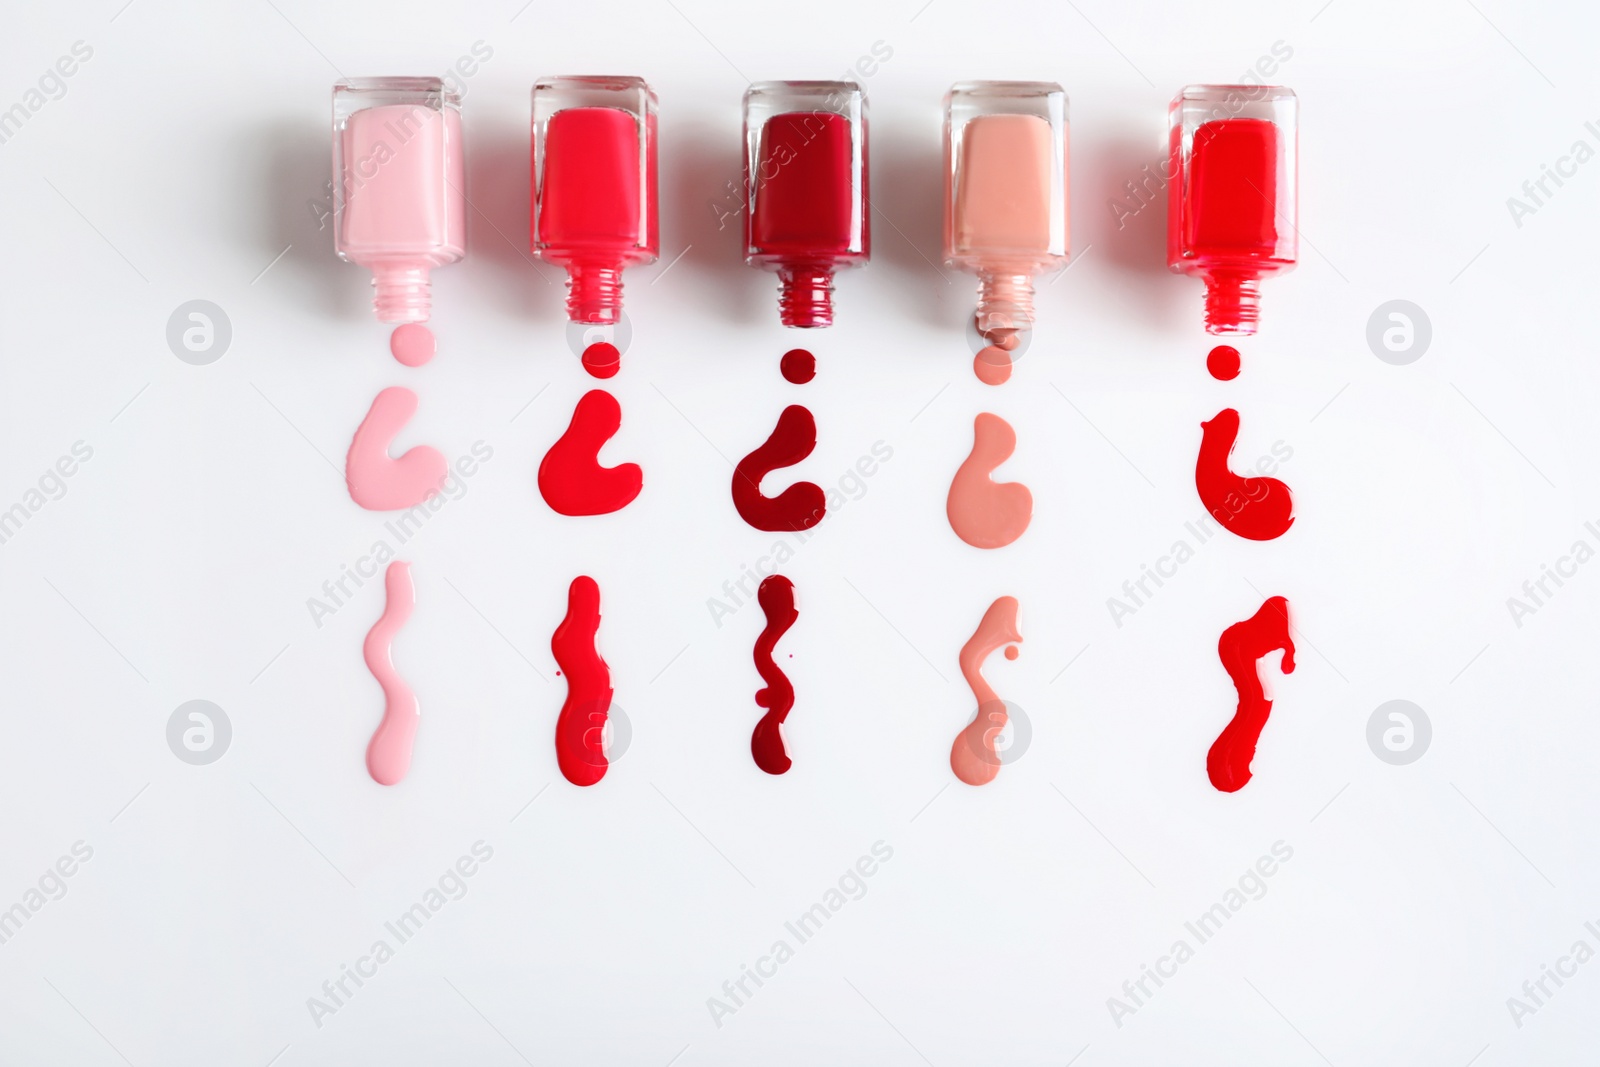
[0,0,1600,1067]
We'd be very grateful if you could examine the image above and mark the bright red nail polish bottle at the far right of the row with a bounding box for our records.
[1166,85,1299,334]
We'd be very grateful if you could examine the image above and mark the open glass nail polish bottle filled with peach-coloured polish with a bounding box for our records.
[944,82,1069,344]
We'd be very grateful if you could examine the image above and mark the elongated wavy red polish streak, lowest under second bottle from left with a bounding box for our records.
[550,574,611,785]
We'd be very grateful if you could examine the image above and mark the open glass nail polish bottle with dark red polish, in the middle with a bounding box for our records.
[744,82,872,328]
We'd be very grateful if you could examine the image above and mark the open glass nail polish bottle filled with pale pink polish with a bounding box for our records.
[333,78,467,323]
